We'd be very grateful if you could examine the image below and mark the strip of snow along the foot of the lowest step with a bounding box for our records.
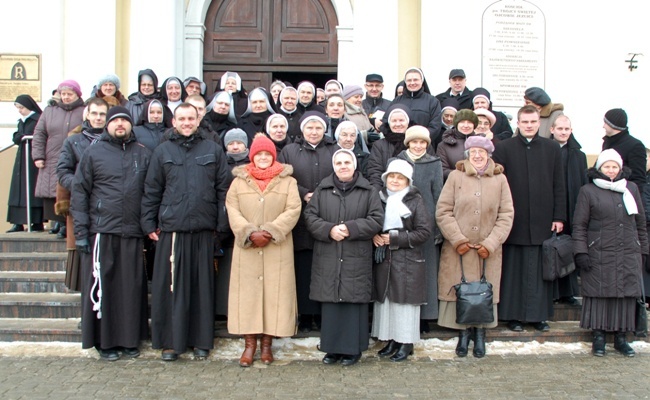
[0,338,650,365]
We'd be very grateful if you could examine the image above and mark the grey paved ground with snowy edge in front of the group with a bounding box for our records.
[0,339,650,400]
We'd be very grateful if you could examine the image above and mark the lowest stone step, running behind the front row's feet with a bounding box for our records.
[0,318,650,343]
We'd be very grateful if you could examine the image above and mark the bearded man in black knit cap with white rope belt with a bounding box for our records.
[70,106,151,361]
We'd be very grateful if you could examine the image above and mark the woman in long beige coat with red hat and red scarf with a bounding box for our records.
[226,137,301,367]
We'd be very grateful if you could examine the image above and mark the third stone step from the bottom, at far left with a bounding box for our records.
[0,271,69,293]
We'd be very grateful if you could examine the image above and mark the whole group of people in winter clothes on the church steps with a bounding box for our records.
[9,68,650,367]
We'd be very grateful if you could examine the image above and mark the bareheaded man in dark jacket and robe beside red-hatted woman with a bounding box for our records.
[141,103,231,361]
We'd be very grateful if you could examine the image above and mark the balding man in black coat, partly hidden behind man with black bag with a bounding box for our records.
[551,115,588,305]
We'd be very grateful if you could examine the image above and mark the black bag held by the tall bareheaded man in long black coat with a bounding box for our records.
[542,232,576,281]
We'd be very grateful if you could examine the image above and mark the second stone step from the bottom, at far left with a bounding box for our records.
[0,293,81,318]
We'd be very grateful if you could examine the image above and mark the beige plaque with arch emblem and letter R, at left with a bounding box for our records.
[0,54,42,102]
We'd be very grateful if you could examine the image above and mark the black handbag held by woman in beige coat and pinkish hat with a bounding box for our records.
[454,256,494,325]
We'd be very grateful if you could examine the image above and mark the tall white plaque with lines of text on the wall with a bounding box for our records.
[481,0,546,107]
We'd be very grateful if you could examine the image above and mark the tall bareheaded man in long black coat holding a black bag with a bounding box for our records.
[492,106,567,332]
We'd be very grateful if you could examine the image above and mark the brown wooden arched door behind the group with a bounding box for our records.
[203,0,338,91]
